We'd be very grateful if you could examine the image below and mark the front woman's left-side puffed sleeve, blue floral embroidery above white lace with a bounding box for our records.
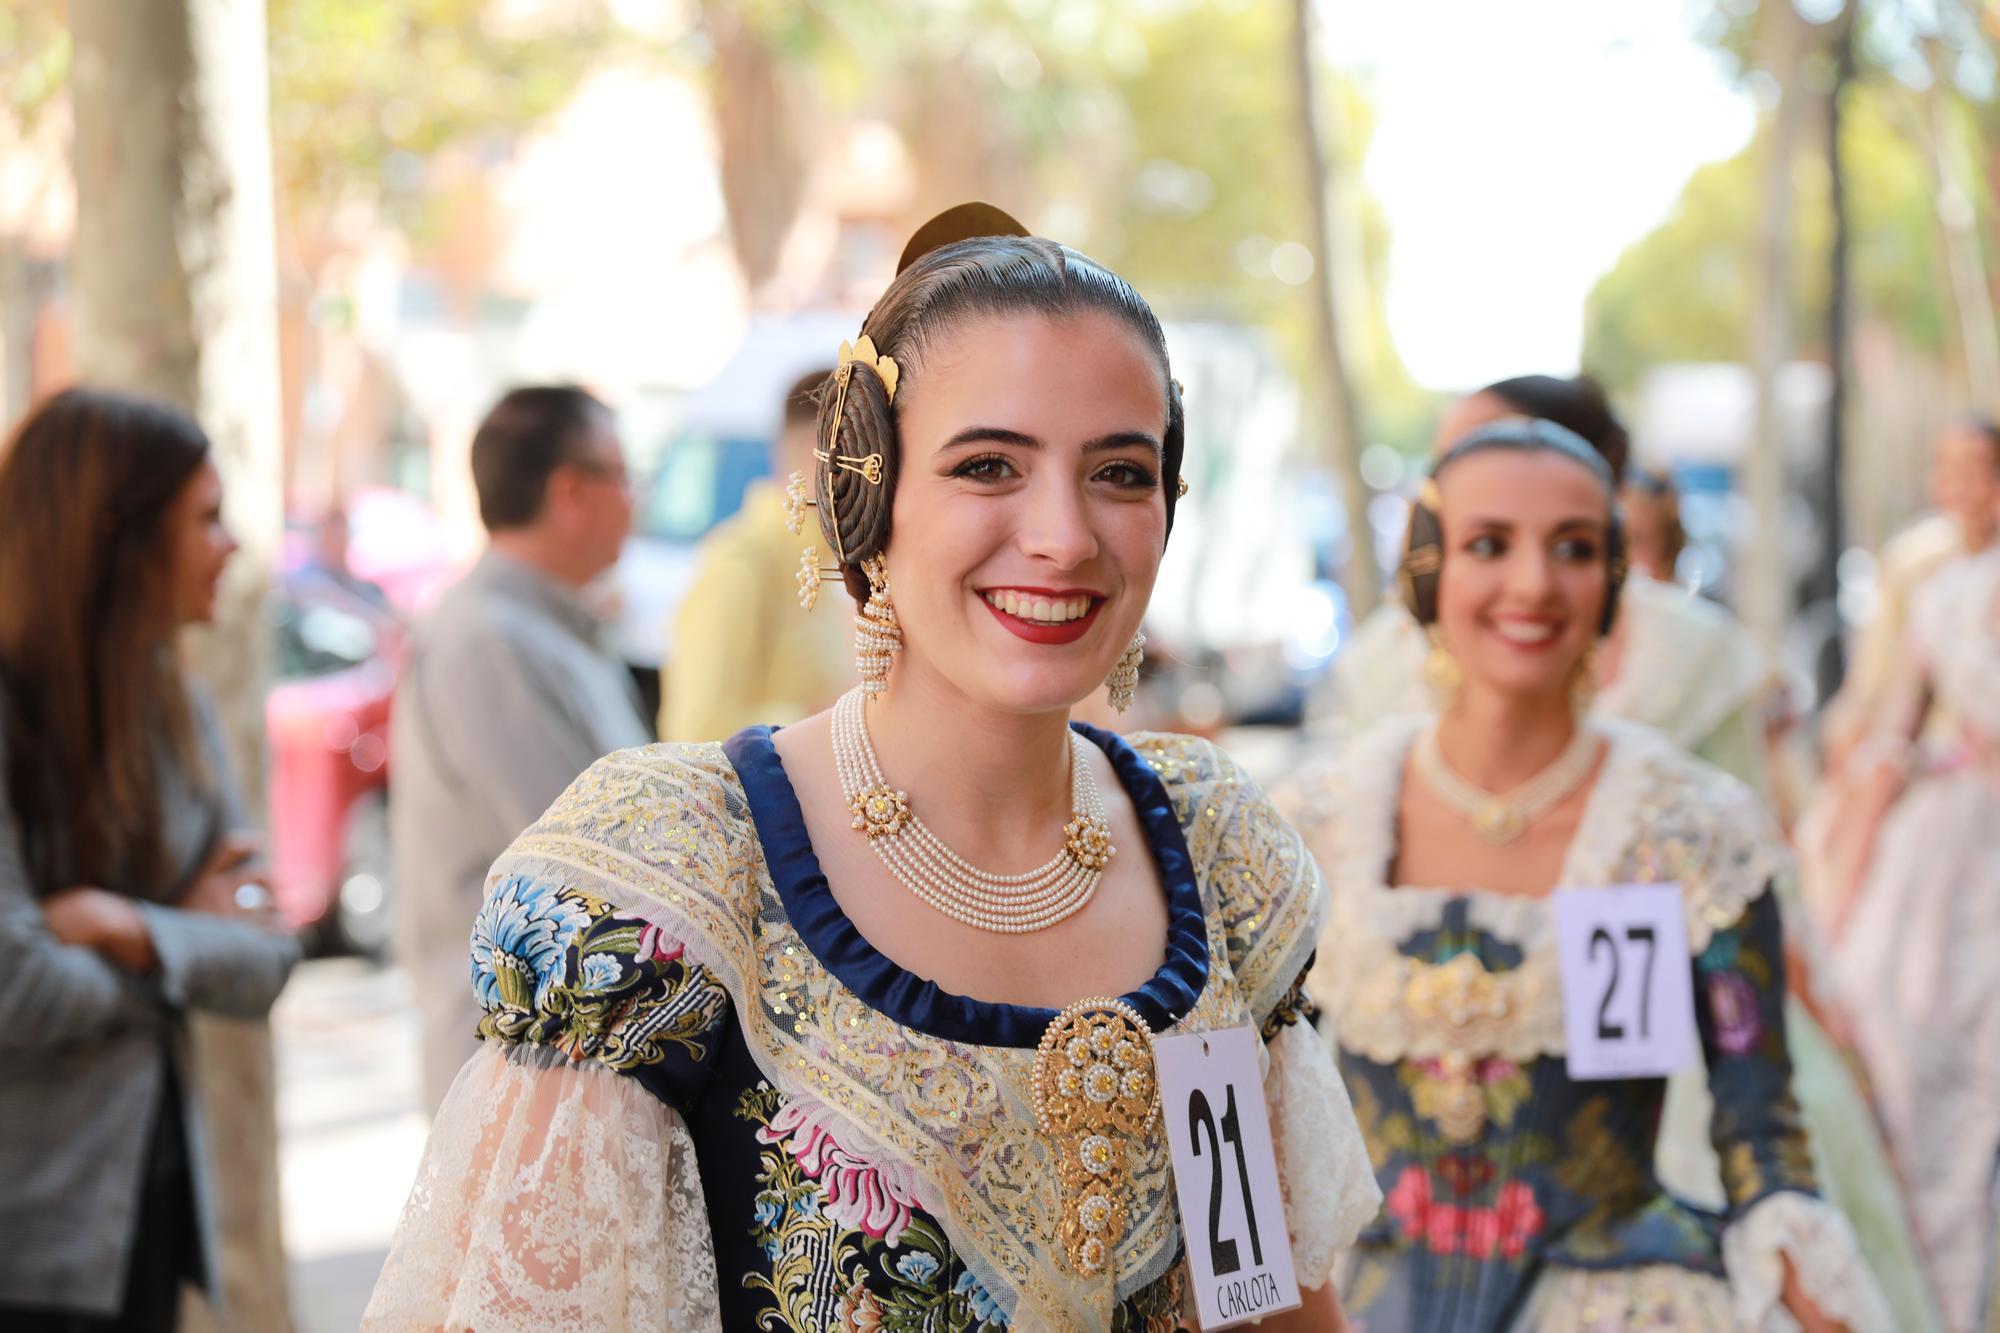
[364,752,732,1333]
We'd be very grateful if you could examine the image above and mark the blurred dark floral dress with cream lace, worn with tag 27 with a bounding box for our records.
[1302,717,1890,1333]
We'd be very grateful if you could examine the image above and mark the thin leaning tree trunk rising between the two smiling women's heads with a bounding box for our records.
[1292,0,1382,620]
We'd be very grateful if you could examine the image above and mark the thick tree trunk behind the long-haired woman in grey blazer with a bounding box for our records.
[70,0,290,1333]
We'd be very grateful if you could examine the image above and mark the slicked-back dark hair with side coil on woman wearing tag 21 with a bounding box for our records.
[814,236,1186,602]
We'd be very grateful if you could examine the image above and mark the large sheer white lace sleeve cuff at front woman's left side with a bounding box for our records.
[362,1041,720,1333]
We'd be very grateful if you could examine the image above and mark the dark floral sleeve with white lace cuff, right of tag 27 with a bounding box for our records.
[1694,889,1890,1333]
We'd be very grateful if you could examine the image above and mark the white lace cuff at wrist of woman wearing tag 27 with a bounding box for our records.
[1722,1191,1894,1333]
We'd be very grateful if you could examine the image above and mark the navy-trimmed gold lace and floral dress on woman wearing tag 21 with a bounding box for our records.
[366,727,1380,1333]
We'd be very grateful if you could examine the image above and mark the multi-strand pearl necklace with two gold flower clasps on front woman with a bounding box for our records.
[834,689,1118,935]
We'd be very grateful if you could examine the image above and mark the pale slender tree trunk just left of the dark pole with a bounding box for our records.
[1742,4,1804,652]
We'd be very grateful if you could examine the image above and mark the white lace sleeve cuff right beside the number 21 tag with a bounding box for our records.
[1264,1023,1382,1287]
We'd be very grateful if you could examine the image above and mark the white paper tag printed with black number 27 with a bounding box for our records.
[1554,885,1696,1081]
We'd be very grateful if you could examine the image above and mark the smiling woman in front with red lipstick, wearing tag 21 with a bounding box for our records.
[366,206,1378,1333]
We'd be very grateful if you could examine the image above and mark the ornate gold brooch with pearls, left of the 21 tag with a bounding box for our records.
[1034,997,1160,1277]
